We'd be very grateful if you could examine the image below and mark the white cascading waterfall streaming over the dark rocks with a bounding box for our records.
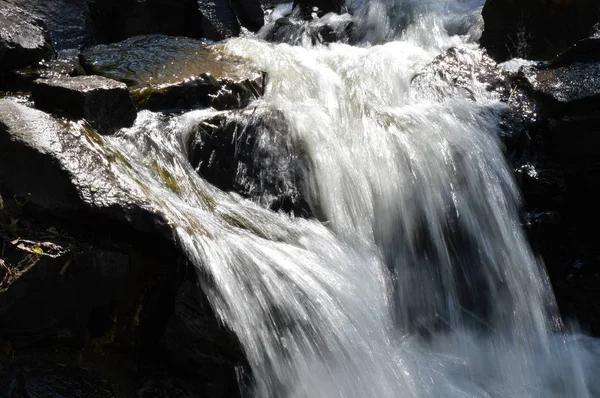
[104,0,600,397]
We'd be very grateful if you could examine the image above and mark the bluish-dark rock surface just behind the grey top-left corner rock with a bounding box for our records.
[6,0,94,50]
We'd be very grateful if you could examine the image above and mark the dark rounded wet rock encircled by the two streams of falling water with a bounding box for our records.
[189,109,312,217]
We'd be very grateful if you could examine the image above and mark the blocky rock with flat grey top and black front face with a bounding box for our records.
[31,76,137,134]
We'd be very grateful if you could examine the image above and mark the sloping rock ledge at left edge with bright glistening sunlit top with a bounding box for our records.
[0,99,173,236]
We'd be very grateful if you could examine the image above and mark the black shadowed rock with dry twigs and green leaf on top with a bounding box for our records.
[0,236,130,347]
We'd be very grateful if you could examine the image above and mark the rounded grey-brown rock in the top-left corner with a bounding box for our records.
[0,0,55,71]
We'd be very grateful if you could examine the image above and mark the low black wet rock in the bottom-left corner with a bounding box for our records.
[0,361,116,398]
